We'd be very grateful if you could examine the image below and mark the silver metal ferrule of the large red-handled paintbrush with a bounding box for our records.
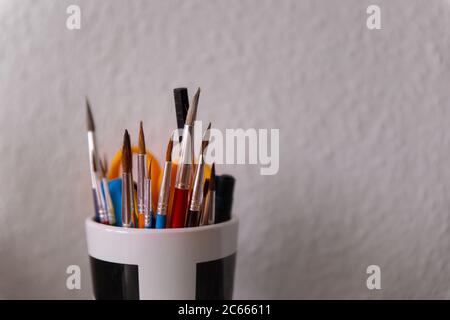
[175,125,194,189]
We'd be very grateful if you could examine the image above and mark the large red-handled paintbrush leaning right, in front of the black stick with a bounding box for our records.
[172,88,200,228]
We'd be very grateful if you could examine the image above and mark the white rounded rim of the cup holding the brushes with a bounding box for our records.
[85,216,239,235]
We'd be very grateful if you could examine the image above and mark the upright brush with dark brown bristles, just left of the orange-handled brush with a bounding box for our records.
[122,130,134,228]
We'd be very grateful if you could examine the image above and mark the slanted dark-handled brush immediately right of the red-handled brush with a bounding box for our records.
[186,123,211,227]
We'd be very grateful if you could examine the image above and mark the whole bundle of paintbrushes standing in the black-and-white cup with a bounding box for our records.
[86,88,234,229]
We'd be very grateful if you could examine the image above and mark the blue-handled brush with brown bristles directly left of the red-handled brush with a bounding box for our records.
[156,136,173,229]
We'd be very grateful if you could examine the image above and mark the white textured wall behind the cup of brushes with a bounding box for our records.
[0,0,450,298]
